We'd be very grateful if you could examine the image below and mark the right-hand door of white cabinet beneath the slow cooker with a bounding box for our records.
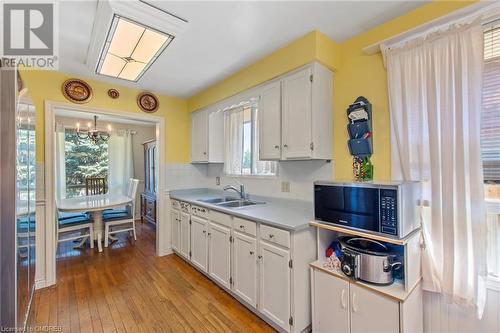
[350,284,399,333]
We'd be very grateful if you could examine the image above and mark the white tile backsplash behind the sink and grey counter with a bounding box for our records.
[166,161,333,201]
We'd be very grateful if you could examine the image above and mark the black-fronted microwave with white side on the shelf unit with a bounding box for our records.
[314,181,420,238]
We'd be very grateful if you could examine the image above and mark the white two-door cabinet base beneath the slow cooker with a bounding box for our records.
[311,268,423,333]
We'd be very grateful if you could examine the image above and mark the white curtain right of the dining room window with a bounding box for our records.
[108,131,134,194]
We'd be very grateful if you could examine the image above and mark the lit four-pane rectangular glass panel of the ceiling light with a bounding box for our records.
[96,15,174,81]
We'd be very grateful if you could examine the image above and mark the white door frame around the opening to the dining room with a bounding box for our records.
[43,101,171,287]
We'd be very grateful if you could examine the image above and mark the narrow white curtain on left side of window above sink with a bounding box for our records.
[224,107,244,175]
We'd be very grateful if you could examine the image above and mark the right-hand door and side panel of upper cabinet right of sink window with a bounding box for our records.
[281,63,333,160]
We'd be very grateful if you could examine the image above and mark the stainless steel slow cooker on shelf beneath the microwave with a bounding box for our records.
[339,237,402,285]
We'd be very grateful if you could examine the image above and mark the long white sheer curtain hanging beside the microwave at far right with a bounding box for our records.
[383,22,487,315]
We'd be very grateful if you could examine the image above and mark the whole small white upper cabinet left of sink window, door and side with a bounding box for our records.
[191,109,224,163]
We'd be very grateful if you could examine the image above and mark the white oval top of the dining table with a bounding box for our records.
[57,193,132,212]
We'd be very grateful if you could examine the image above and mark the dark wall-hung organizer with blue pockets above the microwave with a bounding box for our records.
[347,96,373,181]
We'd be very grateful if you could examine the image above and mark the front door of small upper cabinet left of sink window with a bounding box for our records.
[191,111,208,162]
